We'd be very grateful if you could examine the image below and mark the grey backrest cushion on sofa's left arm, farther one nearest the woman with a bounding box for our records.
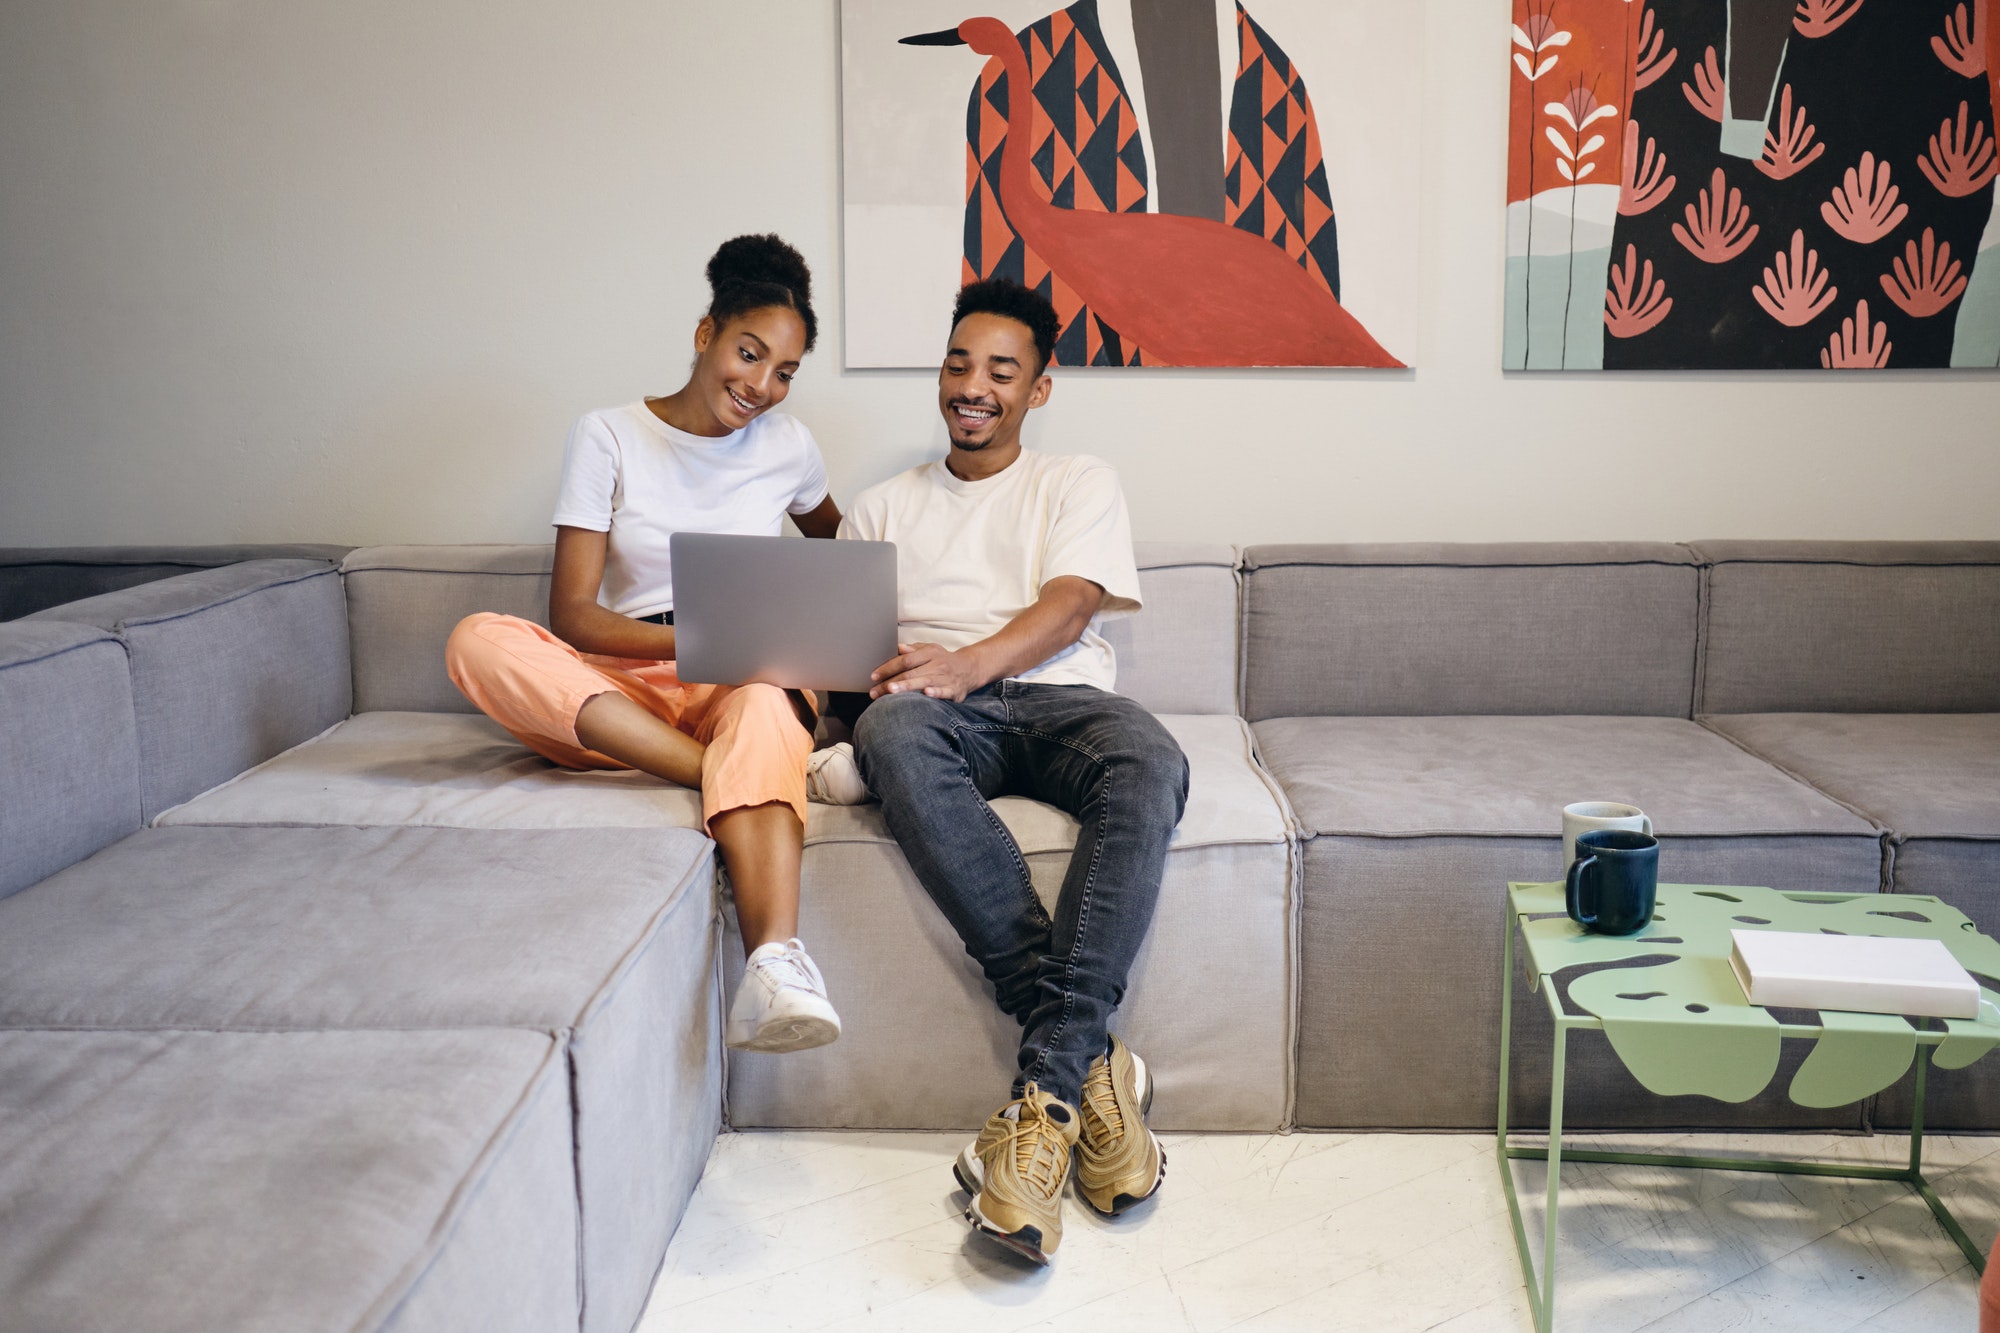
[22,560,352,819]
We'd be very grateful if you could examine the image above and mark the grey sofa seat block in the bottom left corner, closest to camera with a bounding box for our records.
[0,1031,578,1333]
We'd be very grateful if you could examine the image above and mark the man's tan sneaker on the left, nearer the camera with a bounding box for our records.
[952,1083,1078,1265]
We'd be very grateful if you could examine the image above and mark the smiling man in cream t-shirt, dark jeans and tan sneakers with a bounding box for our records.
[840,282,1188,1263]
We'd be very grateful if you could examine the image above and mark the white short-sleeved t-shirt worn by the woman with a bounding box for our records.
[550,402,826,616]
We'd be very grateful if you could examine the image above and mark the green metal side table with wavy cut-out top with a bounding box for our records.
[1496,883,2000,1333]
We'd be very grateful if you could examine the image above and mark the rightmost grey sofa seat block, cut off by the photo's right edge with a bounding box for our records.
[1704,713,2000,1129]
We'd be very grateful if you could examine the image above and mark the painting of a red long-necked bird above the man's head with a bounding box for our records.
[838,0,1424,370]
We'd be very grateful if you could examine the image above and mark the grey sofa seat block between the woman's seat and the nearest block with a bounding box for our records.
[0,829,720,1333]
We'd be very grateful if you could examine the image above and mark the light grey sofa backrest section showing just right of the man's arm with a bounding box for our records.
[1104,542,1238,713]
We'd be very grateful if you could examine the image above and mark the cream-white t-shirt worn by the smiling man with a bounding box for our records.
[840,448,1140,691]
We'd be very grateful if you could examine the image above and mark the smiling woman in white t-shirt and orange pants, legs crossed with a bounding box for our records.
[446,236,858,1051]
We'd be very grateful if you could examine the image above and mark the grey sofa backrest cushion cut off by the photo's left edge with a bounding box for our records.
[0,620,140,899]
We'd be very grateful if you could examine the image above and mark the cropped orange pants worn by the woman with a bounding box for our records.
[444,610,812,827]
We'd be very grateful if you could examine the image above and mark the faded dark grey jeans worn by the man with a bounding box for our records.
[854,681,1188,1107]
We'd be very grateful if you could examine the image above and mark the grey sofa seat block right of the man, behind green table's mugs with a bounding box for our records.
[1256,717,1882,1129]
